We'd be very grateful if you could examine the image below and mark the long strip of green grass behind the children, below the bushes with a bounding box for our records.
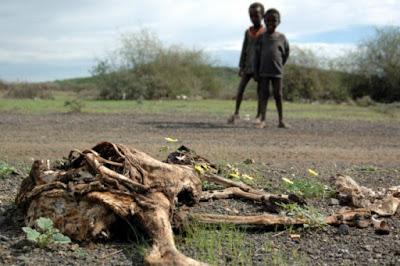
[0,97,400,121]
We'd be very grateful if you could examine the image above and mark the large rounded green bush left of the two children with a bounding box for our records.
[93,30,220,99]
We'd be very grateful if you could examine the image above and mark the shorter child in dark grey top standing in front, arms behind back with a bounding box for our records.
[254,9,289,128]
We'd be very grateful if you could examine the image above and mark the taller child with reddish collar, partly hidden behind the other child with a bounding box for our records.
[228,3,265,124]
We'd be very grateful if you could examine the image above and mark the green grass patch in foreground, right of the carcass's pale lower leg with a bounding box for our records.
[177,222,309,266]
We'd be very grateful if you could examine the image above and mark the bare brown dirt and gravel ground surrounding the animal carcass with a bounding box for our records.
[0,113,400,265]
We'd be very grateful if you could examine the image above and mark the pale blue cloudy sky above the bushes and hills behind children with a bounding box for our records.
[0,0,400,81]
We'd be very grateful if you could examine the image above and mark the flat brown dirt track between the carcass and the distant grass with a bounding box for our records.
[0,113,400,165]
